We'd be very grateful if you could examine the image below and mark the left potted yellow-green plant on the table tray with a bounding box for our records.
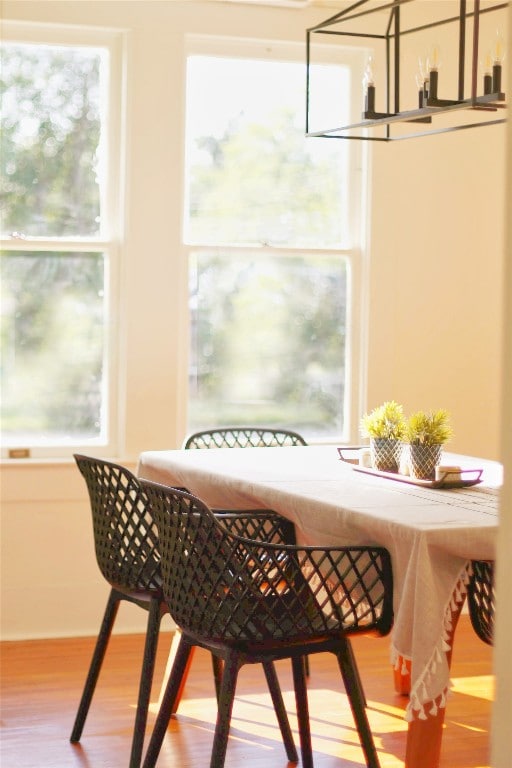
[361,400,406,472]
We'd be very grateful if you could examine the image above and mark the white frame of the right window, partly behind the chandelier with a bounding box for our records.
[182,34,371,445]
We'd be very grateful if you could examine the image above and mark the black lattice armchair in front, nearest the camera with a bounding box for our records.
[141,481,393,768]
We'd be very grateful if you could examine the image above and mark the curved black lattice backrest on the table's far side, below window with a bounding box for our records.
[183,427,307,449]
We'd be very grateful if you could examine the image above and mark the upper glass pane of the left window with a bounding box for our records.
[0,43,106,237]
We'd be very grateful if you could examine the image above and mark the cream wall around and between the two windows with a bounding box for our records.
[1,0,505,656]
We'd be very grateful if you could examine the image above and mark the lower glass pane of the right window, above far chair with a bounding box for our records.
[189,251,348,436]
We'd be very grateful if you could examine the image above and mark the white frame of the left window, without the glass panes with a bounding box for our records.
[0,21,126,459]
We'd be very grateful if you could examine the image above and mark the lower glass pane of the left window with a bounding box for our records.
[1,252,106,445]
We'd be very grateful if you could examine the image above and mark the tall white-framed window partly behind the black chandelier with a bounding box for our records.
[185,39,365,440]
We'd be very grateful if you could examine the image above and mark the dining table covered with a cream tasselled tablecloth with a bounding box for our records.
[137,445,502,768]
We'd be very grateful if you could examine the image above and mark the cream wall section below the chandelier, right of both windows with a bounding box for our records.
[368,125,505,458]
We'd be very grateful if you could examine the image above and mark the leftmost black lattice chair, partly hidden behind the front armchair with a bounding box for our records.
[70,454,169,768]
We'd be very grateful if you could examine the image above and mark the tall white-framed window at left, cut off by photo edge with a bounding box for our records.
[0,26,123,455]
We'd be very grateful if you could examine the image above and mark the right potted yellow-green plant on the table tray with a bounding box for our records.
[405,408,453,480]
